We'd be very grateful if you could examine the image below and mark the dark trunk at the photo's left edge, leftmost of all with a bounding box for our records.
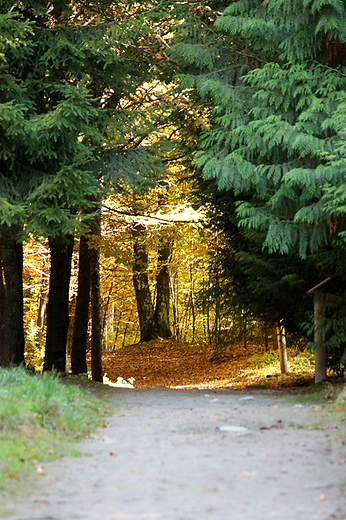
[0,226,24,366]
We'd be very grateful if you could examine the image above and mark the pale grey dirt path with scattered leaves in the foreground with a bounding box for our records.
[3,388,346,520]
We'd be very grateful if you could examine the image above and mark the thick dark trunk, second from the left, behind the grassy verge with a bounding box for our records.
[43,235,74,372]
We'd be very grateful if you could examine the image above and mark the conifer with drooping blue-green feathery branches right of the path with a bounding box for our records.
[176,0,346,382]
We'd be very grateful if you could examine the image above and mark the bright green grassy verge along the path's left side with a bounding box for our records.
[0,368,107,490]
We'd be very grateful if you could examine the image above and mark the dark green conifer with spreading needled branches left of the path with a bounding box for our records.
[0,0,178,369]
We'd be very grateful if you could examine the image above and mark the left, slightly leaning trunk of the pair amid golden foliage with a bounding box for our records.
[132,224,157,343]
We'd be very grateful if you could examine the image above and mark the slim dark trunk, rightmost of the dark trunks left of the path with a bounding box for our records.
[90,214,103,381]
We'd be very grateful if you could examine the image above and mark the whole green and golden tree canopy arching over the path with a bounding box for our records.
[0,0,346,382]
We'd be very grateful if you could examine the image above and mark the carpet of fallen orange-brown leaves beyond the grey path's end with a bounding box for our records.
[99,340,336,389]
